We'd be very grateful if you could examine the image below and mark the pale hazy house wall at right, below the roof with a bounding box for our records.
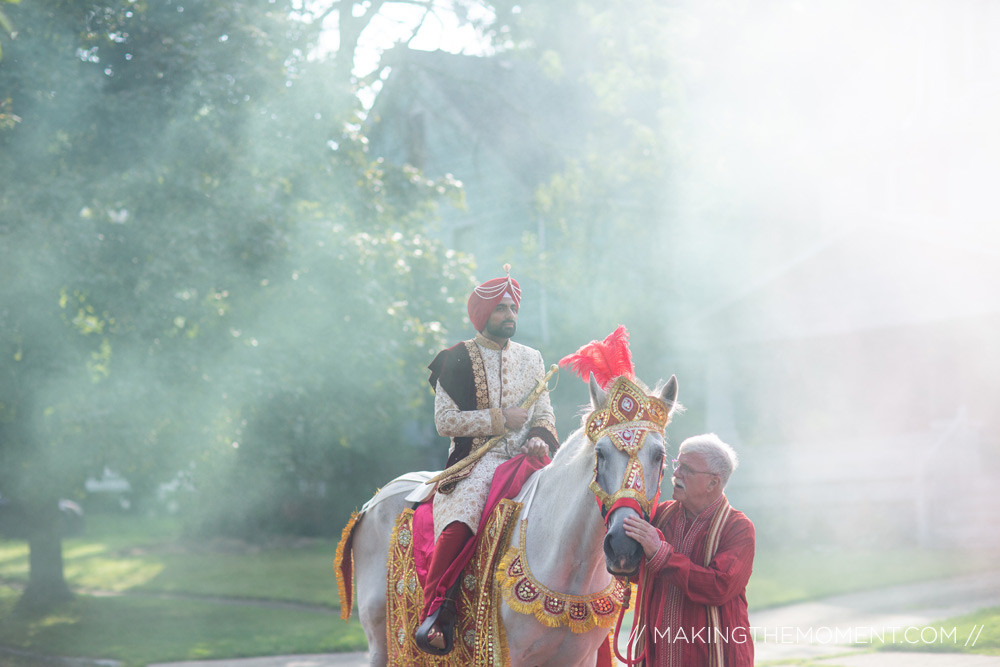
[688,316,1000,546]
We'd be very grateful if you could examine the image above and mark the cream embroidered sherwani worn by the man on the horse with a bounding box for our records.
[434,334,555,539]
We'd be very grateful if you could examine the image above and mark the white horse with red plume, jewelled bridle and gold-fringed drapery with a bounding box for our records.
[335,327,677,667]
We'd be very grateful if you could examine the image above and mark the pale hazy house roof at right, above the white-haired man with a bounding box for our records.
[683,230,1000,343]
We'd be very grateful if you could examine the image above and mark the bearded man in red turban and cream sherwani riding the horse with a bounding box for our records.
[416,265,559,655]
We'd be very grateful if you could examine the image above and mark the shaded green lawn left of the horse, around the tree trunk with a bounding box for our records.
[0,516,367,667]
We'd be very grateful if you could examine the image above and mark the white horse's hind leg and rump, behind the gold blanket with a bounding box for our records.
[354,495,406,667]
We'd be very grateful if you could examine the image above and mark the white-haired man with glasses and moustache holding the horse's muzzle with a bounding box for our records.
[625,434,754,667]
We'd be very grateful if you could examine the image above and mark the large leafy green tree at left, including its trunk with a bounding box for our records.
[0,0,492,607]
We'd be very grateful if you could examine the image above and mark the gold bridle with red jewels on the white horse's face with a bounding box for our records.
[585,376,670,521]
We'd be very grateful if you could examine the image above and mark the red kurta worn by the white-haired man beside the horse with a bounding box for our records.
[646,497,754,667]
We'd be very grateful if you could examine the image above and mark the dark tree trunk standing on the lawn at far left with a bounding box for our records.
[17,502,73,611]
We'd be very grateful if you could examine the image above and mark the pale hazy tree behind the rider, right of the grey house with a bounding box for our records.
[462,0,756,373]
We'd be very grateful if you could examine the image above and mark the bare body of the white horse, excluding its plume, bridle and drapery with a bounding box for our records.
[344,375,677,667]
